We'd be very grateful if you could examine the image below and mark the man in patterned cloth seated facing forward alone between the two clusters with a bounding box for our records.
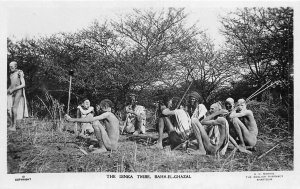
[123,94,146,135]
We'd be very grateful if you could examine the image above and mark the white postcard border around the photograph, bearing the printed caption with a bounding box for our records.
[0,1,300,189]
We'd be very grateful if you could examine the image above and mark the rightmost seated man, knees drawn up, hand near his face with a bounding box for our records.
[229,99,258,148]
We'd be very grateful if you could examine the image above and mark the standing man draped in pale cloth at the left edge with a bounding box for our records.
[7,61,28,131]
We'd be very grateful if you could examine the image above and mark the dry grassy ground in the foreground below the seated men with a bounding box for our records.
[7,119,294,173]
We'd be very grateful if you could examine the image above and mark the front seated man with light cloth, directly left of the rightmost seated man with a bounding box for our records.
[192,103,229,155]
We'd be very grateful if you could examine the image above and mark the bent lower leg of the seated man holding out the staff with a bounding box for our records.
[92,121,112,153]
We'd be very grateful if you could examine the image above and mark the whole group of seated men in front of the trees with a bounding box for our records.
[65,92,258,155]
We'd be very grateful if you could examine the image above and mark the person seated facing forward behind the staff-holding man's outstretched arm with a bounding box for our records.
[75,99,94,137]
